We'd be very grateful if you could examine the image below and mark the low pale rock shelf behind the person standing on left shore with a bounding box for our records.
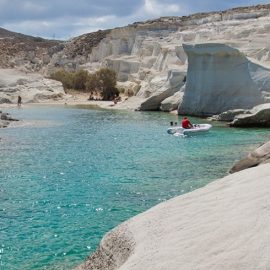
[0,69,65,103]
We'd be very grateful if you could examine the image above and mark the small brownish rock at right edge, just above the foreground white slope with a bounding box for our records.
[230,141,270,173]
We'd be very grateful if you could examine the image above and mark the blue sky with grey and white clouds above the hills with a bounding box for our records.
[0,0,270,40]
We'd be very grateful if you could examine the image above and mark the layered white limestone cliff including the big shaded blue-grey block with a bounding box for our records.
[6,5,270,112]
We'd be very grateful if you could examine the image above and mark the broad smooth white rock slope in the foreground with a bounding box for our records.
[76,164,270,270]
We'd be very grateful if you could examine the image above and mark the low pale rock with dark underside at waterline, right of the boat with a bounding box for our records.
[230,103,270,127]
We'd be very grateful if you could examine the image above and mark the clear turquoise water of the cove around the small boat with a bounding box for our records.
[0,106,270,270]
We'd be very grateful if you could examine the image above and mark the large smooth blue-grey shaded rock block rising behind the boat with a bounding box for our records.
[178,43,270,116]
